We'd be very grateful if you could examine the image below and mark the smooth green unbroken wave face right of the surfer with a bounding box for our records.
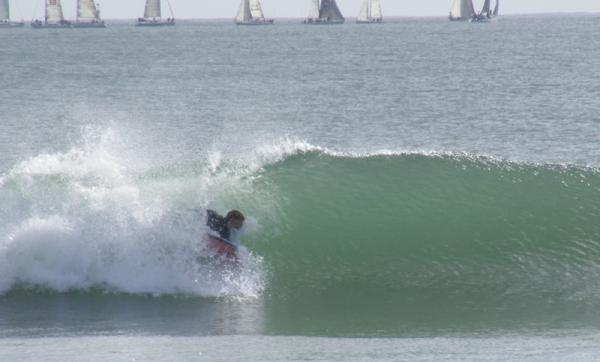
[248,151,600,316]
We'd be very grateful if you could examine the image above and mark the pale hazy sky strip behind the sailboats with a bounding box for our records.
[11,0,600,19]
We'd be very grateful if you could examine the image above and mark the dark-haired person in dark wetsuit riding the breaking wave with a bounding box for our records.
[205,210,245,259]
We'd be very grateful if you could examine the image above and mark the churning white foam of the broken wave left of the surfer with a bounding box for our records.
[0,129,264,298]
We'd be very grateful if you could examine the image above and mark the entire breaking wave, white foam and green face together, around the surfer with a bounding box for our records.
[0,126,600,311]
